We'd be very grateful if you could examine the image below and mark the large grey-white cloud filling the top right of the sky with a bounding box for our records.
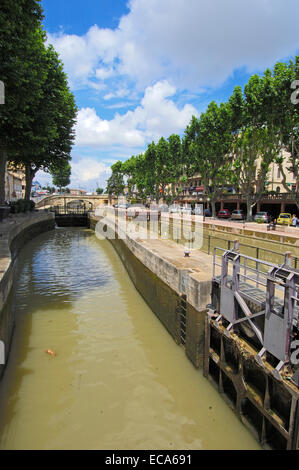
[49,0,299,90]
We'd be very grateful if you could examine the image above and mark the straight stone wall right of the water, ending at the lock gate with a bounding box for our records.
[90,218,212,368]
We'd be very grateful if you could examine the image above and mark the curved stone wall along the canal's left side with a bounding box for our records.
[0,212,55,379]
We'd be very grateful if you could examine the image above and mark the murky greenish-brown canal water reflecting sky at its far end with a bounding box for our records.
[0,229,260,450]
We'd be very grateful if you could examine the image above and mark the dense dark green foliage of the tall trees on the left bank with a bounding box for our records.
[0,0,77,203]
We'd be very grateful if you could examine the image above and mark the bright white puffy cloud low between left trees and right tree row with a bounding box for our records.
[76,80,197,147]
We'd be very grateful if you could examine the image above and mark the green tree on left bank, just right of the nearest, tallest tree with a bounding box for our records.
[14,46,77,199]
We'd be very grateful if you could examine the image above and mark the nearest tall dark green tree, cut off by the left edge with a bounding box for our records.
[0,0,44,204]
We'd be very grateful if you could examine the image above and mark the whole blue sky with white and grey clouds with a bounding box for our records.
[37,0,299,191]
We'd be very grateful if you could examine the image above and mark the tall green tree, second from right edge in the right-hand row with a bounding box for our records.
[229,70,281,220]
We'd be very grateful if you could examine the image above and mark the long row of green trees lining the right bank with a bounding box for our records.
[109,56,299,211]
